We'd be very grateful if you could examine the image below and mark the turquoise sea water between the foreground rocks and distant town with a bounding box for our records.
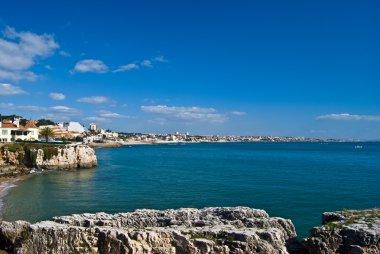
[2,143,380,236]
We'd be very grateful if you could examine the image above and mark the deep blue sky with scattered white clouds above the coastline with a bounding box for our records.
[0,0,380,139]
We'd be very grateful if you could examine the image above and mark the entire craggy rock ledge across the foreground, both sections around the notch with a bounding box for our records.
[0,207,380,254]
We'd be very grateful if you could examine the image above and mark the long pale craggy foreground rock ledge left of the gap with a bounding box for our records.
[0,207,296,254]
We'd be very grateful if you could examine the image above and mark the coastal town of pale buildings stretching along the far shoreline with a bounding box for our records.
[0,115,344,147]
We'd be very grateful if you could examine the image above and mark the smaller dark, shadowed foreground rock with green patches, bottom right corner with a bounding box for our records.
[303,209,380,254]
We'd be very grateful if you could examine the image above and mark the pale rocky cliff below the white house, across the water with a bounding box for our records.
[0,144,97,176]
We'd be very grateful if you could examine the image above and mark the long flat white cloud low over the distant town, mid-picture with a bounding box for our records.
[141,105,227,123]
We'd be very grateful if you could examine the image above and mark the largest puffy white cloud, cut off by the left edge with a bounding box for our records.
[0,27,59,81]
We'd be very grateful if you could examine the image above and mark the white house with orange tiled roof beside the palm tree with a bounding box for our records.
[0,119,39,142]
